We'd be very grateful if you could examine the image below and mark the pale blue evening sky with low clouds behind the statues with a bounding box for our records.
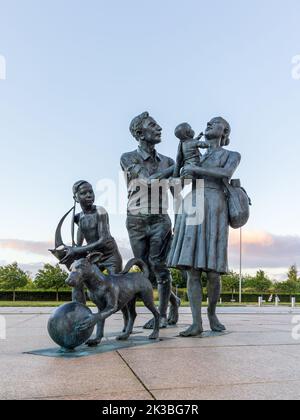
[0,0,300,278]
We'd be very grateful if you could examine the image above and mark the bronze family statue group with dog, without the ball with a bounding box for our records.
[52,112,250,346]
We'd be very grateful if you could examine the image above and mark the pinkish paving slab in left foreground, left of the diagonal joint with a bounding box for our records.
[0,353,145,399]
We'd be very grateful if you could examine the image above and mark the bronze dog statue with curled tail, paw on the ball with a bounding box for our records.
[66,253,159,346]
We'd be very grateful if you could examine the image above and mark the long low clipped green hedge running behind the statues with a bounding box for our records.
[0,289,300,303]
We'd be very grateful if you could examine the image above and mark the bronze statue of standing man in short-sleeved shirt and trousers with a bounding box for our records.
[121,112,180,329]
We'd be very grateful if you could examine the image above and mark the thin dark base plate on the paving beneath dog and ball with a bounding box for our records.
[24,336,168,359]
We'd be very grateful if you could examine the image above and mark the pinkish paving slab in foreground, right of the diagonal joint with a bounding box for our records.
[120,346,300,391]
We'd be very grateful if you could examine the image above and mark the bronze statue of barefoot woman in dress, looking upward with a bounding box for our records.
[168,117,241,337]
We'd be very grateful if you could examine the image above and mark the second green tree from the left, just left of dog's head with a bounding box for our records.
[34,264,68,302]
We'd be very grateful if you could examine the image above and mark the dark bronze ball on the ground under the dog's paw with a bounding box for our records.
[48,302,94,350]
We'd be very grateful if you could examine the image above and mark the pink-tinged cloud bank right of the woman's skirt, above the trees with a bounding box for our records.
[229,231,300,269]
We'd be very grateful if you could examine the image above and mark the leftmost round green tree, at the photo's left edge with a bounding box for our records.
[0,263,30,302]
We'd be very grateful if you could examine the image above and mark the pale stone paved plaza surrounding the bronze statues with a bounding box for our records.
[0,307,300,400]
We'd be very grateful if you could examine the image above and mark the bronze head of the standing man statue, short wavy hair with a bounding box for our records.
[130,112,162,145]
